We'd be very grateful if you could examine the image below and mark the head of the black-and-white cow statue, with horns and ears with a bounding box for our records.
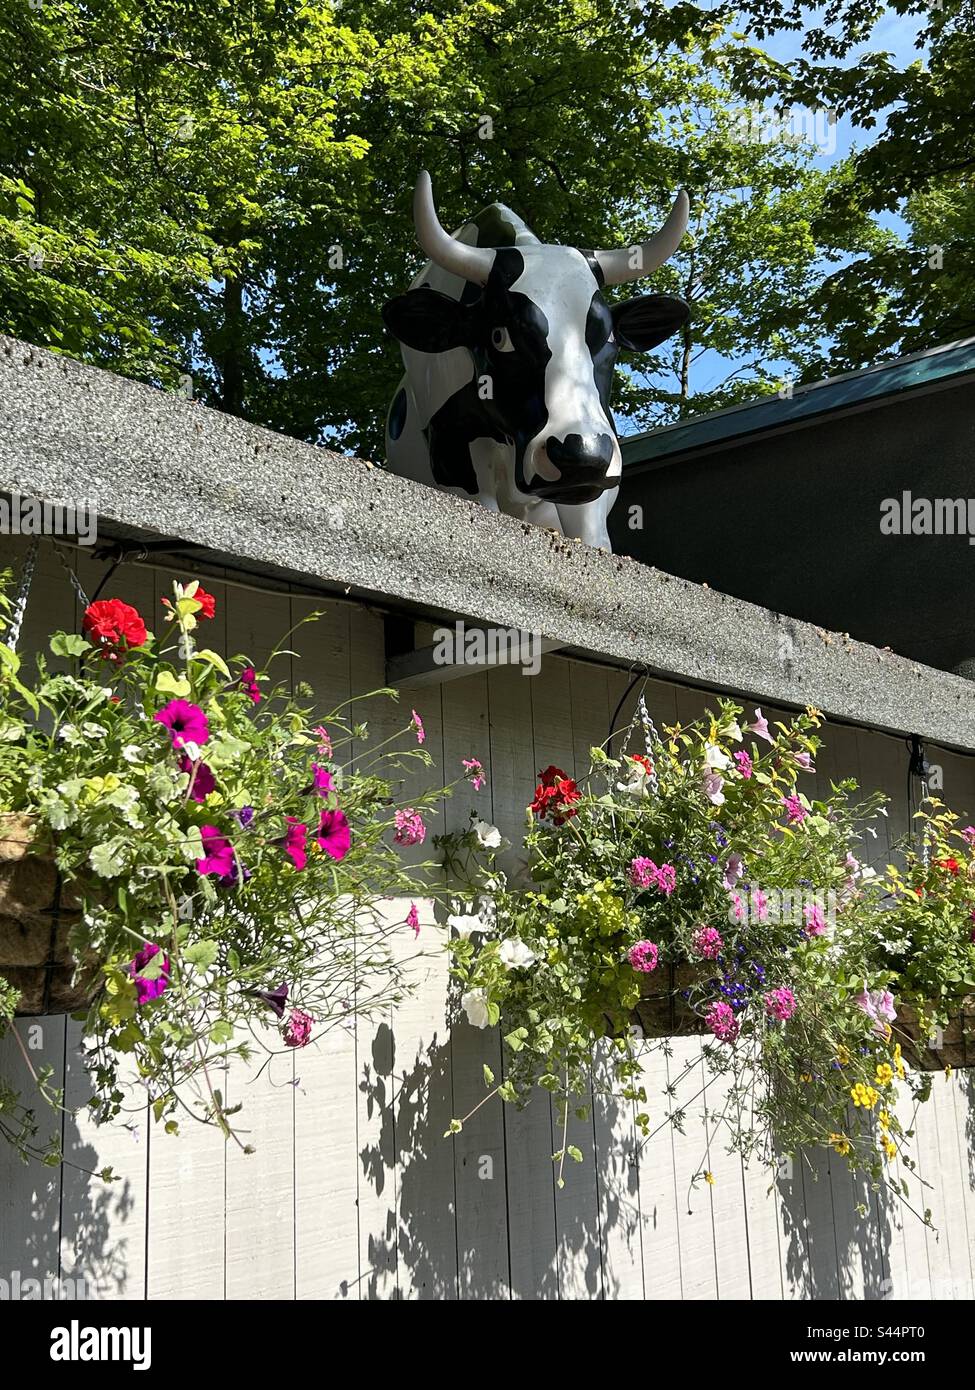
[382,171,688,505]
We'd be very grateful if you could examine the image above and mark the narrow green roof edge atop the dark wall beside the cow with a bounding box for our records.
[620,338,975,471]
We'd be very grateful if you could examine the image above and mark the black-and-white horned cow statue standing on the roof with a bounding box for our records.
[382,170,690,550]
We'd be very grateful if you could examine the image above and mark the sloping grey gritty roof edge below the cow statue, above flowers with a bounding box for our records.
[0,336,975,751]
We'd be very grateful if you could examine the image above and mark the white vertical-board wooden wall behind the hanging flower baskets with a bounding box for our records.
[0,542,975,1300]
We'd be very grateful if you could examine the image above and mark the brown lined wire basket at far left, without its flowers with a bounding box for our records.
[0,815,102,1016]
